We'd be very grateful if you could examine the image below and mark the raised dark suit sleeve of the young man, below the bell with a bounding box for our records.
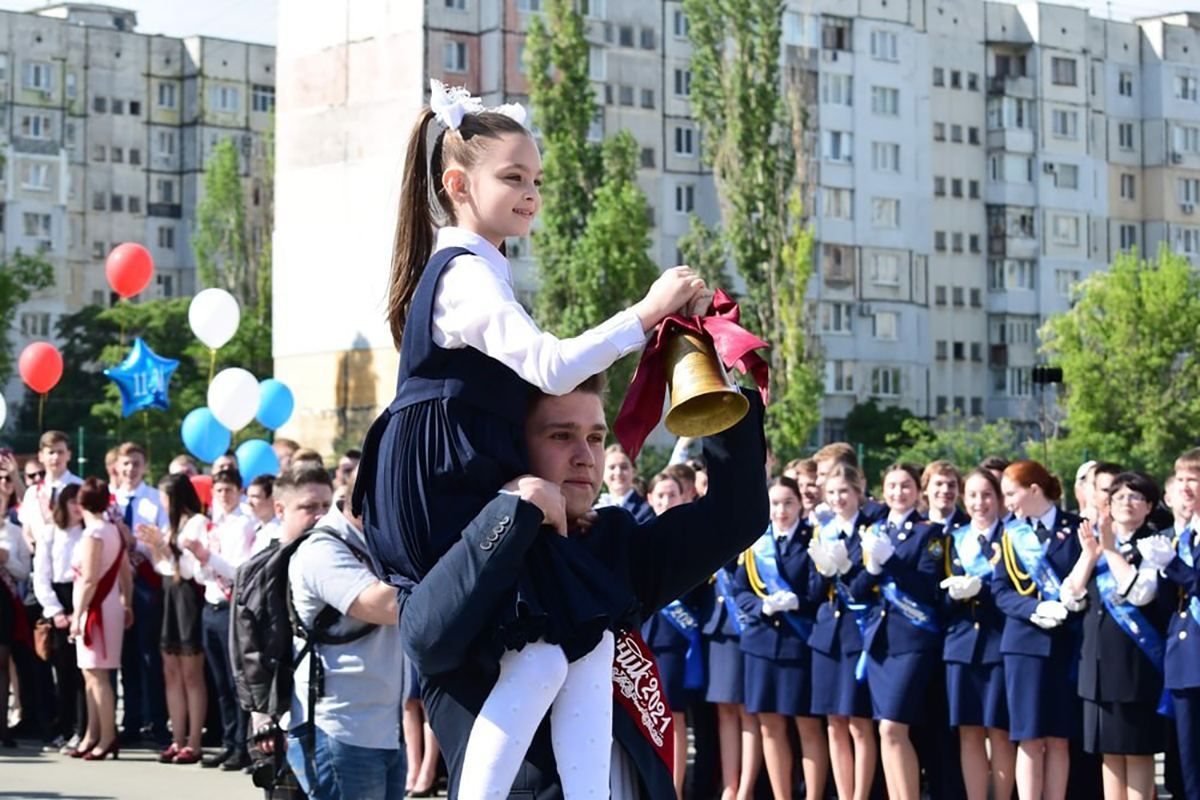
[629,392,768,615]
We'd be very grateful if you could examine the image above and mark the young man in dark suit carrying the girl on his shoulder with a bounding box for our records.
[401,378,767,800]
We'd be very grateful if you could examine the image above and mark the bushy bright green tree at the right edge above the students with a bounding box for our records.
[1040,248,1200,475]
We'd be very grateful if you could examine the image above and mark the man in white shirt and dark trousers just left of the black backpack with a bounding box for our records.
[184,469,254,771]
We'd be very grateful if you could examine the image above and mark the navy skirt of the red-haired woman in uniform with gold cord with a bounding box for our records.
[1004,643,1080,741]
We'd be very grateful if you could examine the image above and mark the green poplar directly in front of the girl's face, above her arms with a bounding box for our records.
[526,0,658,422]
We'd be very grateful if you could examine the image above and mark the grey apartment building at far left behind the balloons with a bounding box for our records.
[0,2,275,397]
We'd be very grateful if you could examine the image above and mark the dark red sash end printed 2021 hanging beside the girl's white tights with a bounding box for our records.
[612,630,674,772]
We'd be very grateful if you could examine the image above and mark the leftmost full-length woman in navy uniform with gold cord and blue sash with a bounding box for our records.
[736,477,829,800]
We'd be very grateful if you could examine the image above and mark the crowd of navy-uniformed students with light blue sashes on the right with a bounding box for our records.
[624,444,1200,800]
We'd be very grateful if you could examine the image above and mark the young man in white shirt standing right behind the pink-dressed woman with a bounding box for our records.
[113,441,170,747]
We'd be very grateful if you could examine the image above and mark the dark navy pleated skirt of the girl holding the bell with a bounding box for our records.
[356,398,637,663]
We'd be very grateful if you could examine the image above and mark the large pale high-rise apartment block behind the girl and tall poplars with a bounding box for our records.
[276,0,1200,450]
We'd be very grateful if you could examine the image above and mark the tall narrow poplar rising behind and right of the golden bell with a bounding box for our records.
[683,0,822,457]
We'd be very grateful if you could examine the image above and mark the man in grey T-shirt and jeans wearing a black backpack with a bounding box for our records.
[232,464,406,800]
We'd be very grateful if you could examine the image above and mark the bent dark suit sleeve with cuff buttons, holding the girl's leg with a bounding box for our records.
[400,493,550,675]
